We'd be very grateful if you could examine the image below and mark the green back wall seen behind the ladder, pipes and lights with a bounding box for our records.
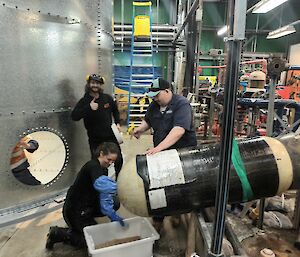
[114,0,300,84]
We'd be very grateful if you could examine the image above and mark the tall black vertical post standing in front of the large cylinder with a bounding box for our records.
[209,0,241,256]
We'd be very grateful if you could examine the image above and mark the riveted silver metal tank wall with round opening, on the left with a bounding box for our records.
[0,0,113,215]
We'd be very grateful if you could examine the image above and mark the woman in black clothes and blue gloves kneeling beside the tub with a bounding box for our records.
[46,142,124,249]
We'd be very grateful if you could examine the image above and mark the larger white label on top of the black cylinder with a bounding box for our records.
[147,149,185,189]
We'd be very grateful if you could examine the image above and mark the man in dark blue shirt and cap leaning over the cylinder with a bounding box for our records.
[132,78,197,154]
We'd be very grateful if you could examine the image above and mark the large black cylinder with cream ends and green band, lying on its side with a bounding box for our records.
[118,136,300,216]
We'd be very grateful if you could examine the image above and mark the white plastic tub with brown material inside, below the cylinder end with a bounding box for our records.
[83,217,159,257]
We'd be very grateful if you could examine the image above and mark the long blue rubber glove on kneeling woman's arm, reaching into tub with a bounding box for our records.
[94,176,125,226]
